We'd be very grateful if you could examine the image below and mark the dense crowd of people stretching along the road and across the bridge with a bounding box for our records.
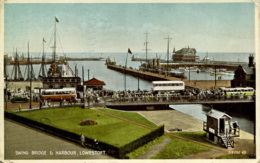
[12,88,254,107]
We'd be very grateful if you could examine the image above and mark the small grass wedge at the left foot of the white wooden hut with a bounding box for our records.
[171,131,216,145]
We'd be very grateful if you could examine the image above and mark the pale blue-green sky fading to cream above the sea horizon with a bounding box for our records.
[4,3,255,53]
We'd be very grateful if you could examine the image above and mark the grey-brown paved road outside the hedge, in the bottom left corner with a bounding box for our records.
[4,120,113,160]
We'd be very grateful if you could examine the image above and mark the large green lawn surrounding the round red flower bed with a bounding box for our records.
[16,107,151,147]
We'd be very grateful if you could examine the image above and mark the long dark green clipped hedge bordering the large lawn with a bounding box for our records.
[4,111,164,158]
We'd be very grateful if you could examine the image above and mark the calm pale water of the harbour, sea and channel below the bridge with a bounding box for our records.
[7,53,254,133]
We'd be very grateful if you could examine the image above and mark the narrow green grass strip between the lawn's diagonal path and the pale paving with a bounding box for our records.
[95,108,158,128]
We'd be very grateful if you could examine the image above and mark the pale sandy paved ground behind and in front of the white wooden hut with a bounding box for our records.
[138,110,256,159]
